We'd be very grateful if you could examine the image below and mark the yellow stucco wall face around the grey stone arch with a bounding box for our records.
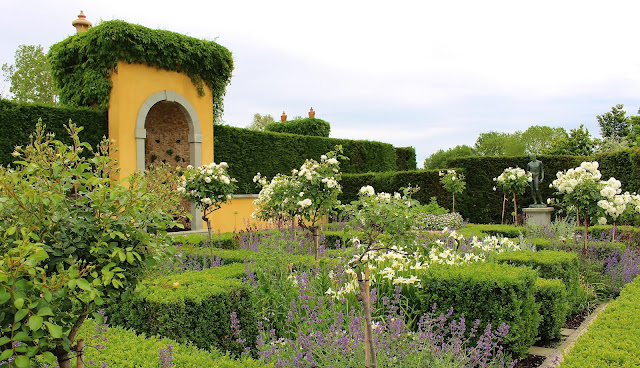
[109,61,213,179]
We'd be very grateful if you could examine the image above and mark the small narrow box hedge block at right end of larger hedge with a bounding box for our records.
[535,278,569,342]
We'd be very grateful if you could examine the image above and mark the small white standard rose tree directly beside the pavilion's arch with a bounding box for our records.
[177,162,237,241]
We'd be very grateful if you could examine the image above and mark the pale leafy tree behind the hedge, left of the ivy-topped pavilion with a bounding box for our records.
[2,45,56,104]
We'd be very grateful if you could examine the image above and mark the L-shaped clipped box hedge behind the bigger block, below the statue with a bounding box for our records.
[496,250,580,312]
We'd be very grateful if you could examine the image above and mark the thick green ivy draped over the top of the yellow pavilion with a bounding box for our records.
[48,20,233,118]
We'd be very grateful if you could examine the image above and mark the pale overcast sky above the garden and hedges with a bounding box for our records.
[0,0,640,166]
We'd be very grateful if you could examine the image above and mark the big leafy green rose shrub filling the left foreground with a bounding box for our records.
[0,124,179,365]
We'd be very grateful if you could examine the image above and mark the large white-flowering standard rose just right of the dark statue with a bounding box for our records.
[549,161,640,249]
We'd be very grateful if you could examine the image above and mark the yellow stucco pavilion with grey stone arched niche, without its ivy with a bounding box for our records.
[67,12,257,232]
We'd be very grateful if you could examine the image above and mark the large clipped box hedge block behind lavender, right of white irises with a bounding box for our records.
[415,263,540,356]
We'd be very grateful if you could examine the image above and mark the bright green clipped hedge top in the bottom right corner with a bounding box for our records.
[560,277,640,368]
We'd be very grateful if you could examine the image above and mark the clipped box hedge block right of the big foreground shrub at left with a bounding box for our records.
[108,264,257,355]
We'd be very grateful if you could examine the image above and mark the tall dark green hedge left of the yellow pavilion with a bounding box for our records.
[0,99,109,166]
